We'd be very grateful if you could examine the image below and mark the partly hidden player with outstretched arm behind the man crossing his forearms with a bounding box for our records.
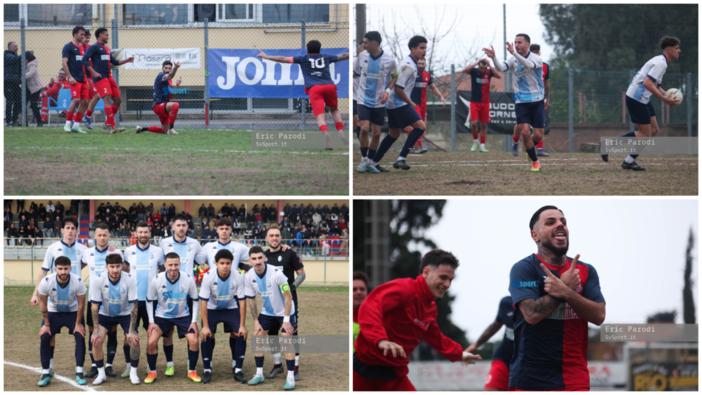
[466,296,514,391]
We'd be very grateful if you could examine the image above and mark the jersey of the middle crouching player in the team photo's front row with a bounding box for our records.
[147,271,199,319]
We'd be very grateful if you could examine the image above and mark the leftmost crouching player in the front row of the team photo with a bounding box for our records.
[38,256,87,387]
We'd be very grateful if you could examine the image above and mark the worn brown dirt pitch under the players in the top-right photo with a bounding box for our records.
[353,152,698,196]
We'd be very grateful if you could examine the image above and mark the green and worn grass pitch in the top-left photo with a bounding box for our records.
[4,124,349,195]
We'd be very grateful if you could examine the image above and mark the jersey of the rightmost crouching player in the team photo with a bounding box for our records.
[244,264,295,317]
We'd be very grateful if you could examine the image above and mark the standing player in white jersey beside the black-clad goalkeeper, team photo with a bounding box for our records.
[195,218,250,383]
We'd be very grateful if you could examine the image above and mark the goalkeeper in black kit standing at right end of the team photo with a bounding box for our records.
[264,225,306,381]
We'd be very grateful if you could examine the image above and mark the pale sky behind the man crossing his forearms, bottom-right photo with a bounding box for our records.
[420,197,699,342]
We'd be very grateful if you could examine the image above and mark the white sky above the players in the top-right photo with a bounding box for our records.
[351,2,553,72]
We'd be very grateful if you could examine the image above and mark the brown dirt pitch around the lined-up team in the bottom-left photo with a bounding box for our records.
[4,287,349,392]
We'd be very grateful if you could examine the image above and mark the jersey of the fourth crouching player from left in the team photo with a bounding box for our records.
[200,268,246,310]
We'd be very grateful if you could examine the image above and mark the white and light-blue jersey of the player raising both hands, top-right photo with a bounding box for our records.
[501,52,544,103]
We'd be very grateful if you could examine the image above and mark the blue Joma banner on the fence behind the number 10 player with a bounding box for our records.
[208,48,349,99]
